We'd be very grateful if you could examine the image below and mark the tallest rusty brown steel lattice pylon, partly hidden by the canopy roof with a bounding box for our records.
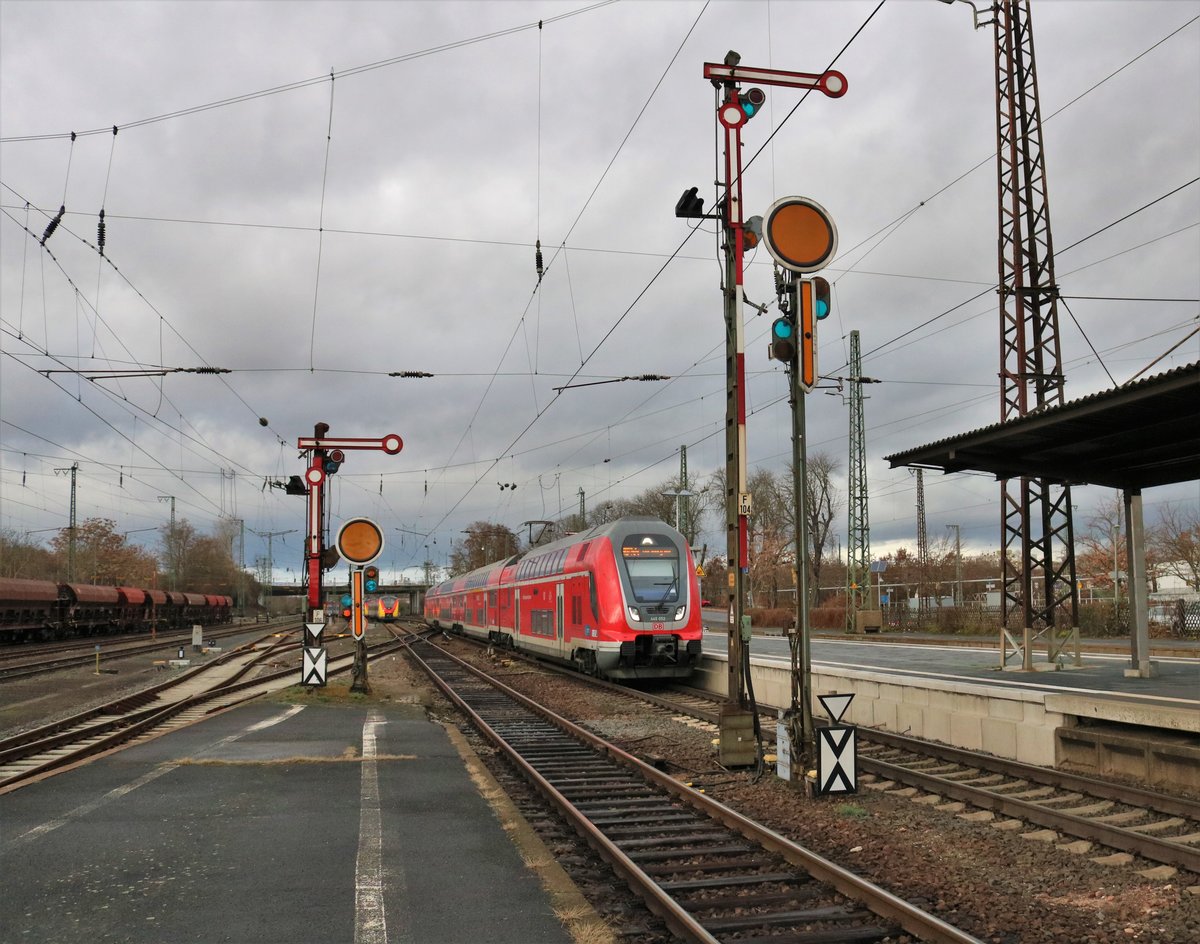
[994,0,1079,668]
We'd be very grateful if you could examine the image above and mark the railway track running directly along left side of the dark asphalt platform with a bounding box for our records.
[0,633,422,793]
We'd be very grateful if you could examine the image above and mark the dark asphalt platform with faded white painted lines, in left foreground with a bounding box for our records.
[0,699,589,944]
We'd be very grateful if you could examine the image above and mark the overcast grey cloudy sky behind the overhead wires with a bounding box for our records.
[0,0,1200,575]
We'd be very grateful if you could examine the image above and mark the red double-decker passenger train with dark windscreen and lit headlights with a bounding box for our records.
[425,518,703,679]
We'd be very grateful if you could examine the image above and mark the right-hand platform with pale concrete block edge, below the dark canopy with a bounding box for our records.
[696,632,1200,793]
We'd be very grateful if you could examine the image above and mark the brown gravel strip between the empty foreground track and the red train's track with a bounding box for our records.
[412,643,1200,944]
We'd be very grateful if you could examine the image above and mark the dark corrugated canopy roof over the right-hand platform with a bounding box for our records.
[884,362,1200,489]
